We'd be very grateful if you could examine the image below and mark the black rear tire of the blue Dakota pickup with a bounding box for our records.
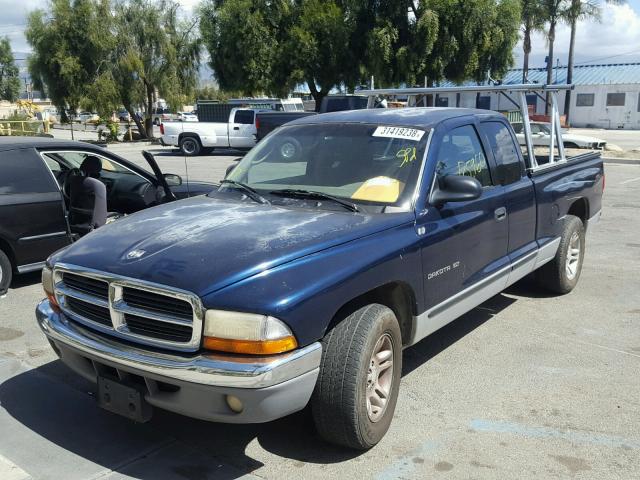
[536,215,585,295]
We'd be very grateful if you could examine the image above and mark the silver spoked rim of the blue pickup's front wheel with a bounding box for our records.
[366,333,393,422]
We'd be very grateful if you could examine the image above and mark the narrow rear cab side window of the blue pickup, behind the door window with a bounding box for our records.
[480,122,522,185]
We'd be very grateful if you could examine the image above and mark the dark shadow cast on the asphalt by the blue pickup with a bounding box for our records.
[0,285,537,480]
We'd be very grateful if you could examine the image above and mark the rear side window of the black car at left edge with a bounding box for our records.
[0,149,58,195]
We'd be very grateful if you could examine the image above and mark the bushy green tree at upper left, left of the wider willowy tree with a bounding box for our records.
[25,0,115,120]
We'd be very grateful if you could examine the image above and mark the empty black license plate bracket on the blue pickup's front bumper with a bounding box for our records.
[98,376,153,423]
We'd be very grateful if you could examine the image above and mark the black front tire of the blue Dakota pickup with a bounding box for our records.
[311,304,402,450]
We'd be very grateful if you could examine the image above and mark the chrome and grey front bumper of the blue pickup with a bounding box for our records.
[36,300,322,423]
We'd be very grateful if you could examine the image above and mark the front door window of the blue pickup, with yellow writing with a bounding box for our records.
[436,125,493,187]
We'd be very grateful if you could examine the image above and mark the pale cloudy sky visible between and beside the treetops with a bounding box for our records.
[0,0,640,73]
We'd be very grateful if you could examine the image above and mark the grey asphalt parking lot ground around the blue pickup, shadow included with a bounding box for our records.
[0,162,640,480]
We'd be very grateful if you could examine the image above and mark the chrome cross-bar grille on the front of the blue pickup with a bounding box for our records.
[54,264,204,351]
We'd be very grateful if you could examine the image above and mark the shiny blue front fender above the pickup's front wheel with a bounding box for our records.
[203,222,423,345]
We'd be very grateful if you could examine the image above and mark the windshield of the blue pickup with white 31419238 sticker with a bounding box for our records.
[227,123,428,206]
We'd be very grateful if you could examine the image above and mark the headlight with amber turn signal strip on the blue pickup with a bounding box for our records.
[204,310,298,355]
